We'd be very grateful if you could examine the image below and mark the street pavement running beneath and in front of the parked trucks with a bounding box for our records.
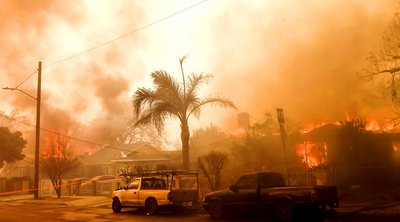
[0,198,400,222]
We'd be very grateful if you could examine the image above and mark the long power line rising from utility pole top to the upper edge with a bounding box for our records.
[43,0,208,68]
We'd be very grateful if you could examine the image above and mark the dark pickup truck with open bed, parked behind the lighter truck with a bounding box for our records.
[203,172,339,221]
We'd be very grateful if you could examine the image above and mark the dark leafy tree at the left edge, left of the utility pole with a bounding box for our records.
[0,127,26,168]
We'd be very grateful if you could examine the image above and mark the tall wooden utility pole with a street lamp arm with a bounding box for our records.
[3,62,42,199]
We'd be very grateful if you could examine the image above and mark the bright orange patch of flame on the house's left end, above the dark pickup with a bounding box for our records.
[296,141,328,167]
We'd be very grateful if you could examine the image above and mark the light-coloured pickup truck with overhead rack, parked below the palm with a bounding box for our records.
[112,171,199,215]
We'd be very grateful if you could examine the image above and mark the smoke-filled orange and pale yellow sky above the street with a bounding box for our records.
[0,0,398,153]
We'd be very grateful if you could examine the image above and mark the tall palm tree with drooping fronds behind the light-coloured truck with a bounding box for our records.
[133,56,235,169]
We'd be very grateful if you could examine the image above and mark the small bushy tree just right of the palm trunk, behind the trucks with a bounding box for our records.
[197,151,228,191]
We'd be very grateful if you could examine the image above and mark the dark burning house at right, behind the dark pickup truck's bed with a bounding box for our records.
[295,120,400,192]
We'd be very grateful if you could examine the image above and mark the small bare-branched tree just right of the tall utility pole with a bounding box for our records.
[40,130,79,198]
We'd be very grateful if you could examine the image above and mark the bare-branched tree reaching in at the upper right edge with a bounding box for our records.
[364,11,400,120]
